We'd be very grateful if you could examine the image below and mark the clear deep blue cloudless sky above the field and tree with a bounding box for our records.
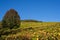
[0,0,60,22]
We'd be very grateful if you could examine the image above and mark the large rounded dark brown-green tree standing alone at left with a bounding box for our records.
[2,9,20,29]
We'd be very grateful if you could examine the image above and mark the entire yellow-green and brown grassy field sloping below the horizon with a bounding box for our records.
[1,21,60,40]
